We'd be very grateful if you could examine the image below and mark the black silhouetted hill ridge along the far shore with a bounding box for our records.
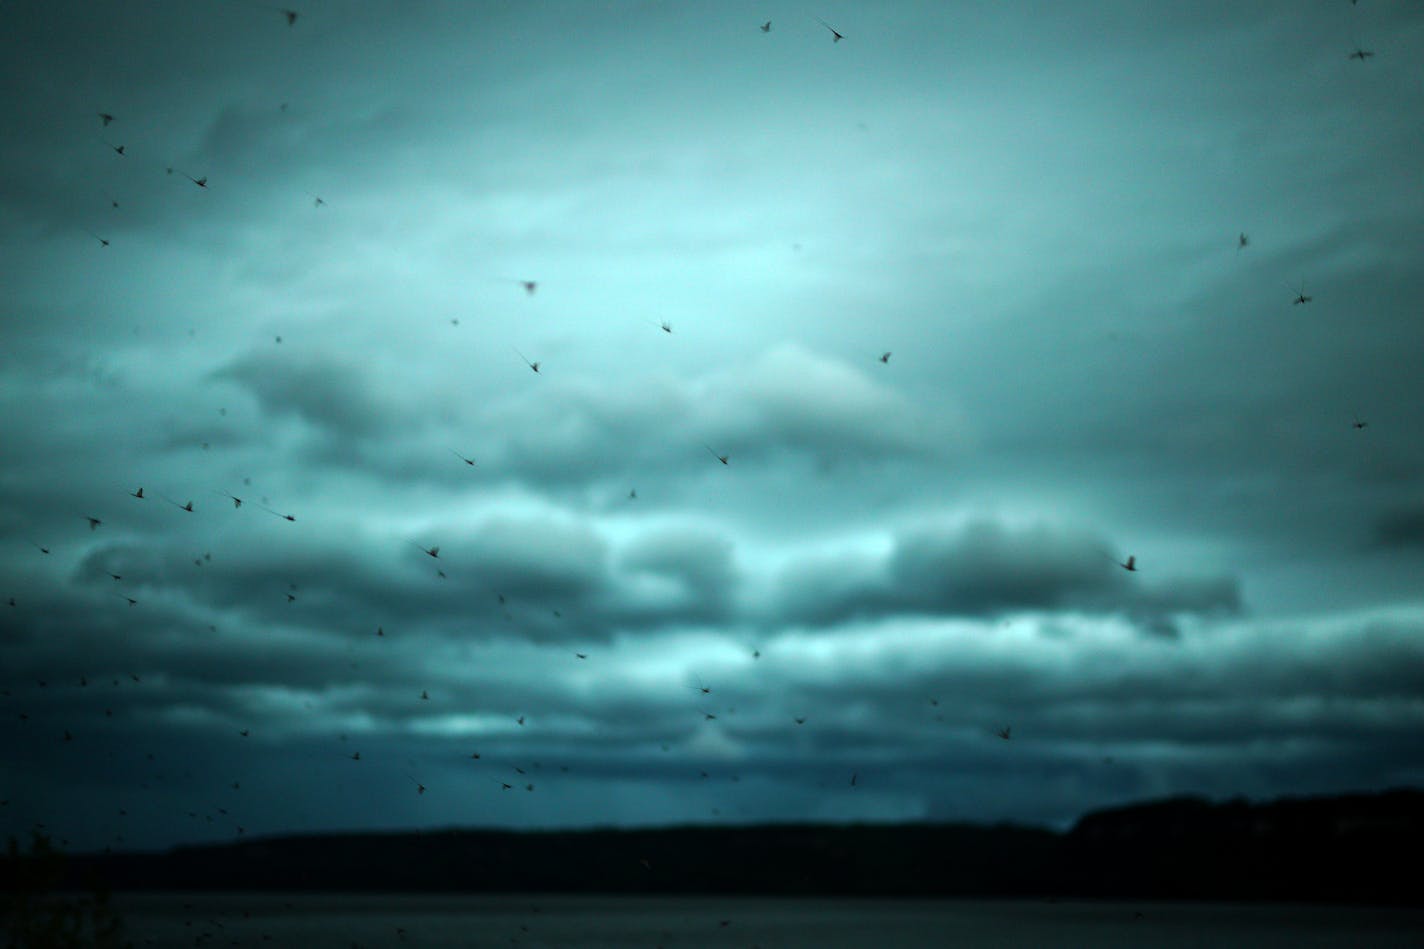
[0,789,1424,905]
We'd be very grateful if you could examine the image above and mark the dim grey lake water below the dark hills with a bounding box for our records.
[114,893,1424,949]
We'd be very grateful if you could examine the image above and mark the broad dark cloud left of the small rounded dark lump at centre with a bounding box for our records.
[62,512,589,638]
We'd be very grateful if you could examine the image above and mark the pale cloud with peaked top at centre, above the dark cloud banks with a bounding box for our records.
[467,343,956,482]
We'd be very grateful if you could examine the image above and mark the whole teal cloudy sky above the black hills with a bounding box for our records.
[0,0,1424,849]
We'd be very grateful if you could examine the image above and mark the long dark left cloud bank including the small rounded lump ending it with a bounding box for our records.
[47,507,740,655]
